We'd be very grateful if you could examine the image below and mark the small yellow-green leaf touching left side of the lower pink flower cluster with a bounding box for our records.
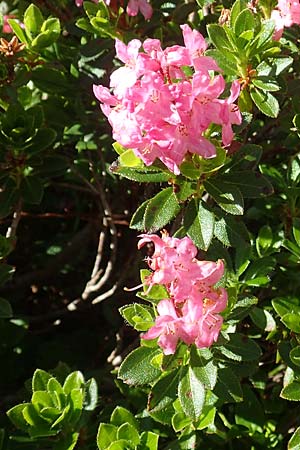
[119,303,155,331]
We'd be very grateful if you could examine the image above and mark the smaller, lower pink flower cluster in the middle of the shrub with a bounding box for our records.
[138,232,227,355]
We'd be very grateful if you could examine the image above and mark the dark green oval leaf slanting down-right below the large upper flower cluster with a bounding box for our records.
[204,179,244,215]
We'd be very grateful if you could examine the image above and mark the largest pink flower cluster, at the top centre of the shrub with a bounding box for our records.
[94,25,241,174]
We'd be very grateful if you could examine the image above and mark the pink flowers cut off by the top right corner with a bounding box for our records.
[271,0,300,41]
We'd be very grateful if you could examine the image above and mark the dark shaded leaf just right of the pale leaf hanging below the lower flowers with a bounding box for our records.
[214,367,243,403]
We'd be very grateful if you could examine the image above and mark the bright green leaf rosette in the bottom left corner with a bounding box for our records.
[7,369,98,450]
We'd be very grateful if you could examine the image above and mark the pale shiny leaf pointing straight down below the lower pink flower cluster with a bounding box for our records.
[178,366,205,420]
